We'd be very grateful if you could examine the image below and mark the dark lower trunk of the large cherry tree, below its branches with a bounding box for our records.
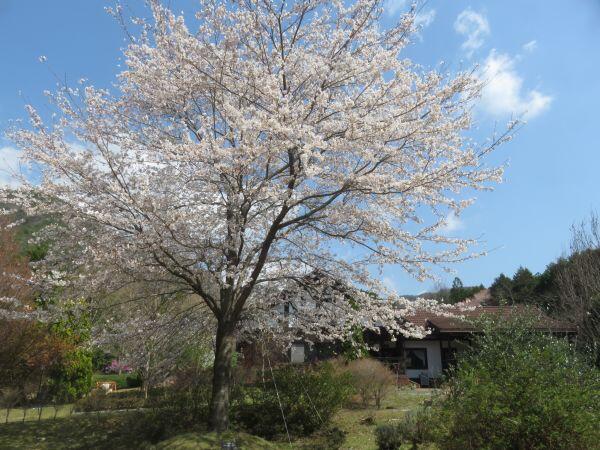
[210,322,235,433]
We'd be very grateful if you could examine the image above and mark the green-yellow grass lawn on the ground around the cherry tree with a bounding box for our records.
[0,389,431,450]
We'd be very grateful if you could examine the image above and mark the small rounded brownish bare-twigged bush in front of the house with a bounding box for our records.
[348,358,396,408]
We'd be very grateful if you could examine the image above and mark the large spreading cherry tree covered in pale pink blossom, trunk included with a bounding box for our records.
[4,0,514,430]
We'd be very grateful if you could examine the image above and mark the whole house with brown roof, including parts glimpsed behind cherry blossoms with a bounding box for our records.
[246,282,576,384]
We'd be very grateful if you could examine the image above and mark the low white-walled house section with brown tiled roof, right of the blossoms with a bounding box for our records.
[366,289,576,384]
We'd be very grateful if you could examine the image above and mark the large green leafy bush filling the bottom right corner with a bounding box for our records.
[430,321,600,450]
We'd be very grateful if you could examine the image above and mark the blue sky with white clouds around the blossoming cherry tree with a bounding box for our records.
[0,0,600,294]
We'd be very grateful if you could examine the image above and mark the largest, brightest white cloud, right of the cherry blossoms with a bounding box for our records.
[479,50,552,120]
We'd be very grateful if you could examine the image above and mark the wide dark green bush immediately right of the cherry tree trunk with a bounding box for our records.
[233,363,353,438]
